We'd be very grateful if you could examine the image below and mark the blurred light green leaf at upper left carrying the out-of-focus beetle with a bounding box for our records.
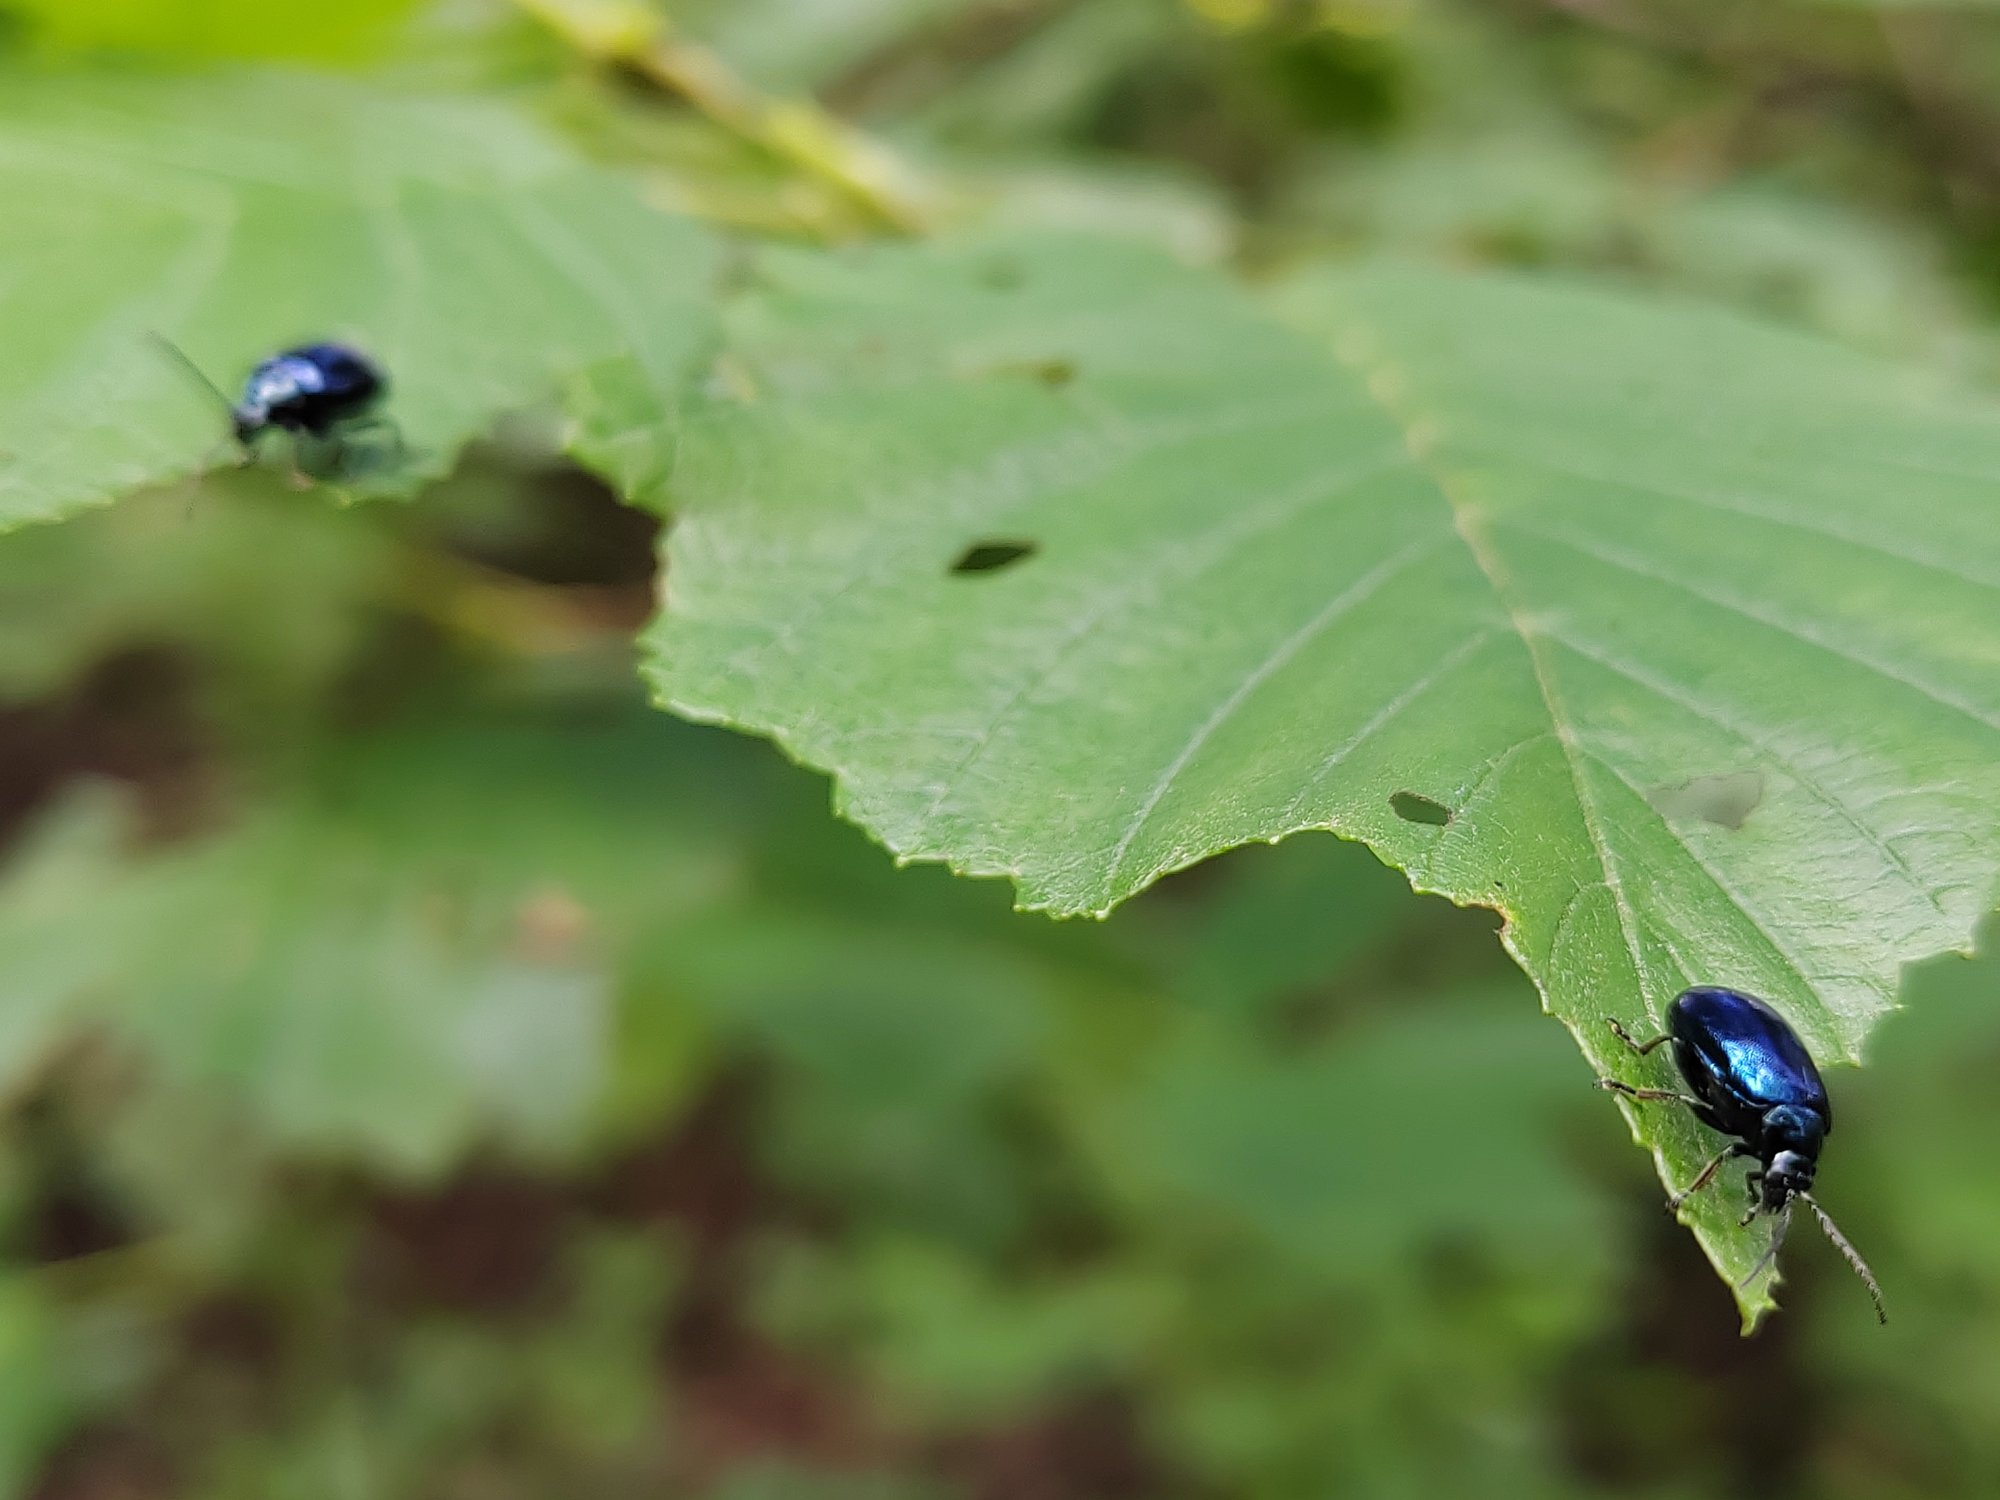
[0,74,712,530]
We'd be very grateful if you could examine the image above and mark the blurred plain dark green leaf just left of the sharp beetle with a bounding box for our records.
[1114,986,1606,1280]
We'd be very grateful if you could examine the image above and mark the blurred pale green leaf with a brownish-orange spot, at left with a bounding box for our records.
[0,722,730,1172]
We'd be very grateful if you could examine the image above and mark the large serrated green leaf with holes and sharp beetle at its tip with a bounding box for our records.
[648,229,2000,1318]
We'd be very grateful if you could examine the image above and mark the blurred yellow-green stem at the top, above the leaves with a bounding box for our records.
[516,0,928,234]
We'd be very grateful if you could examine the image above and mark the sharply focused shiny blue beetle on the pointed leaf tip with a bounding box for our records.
[1598,986,1888,1322]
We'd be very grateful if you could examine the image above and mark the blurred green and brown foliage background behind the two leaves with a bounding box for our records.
[0,0,2000,1500]
